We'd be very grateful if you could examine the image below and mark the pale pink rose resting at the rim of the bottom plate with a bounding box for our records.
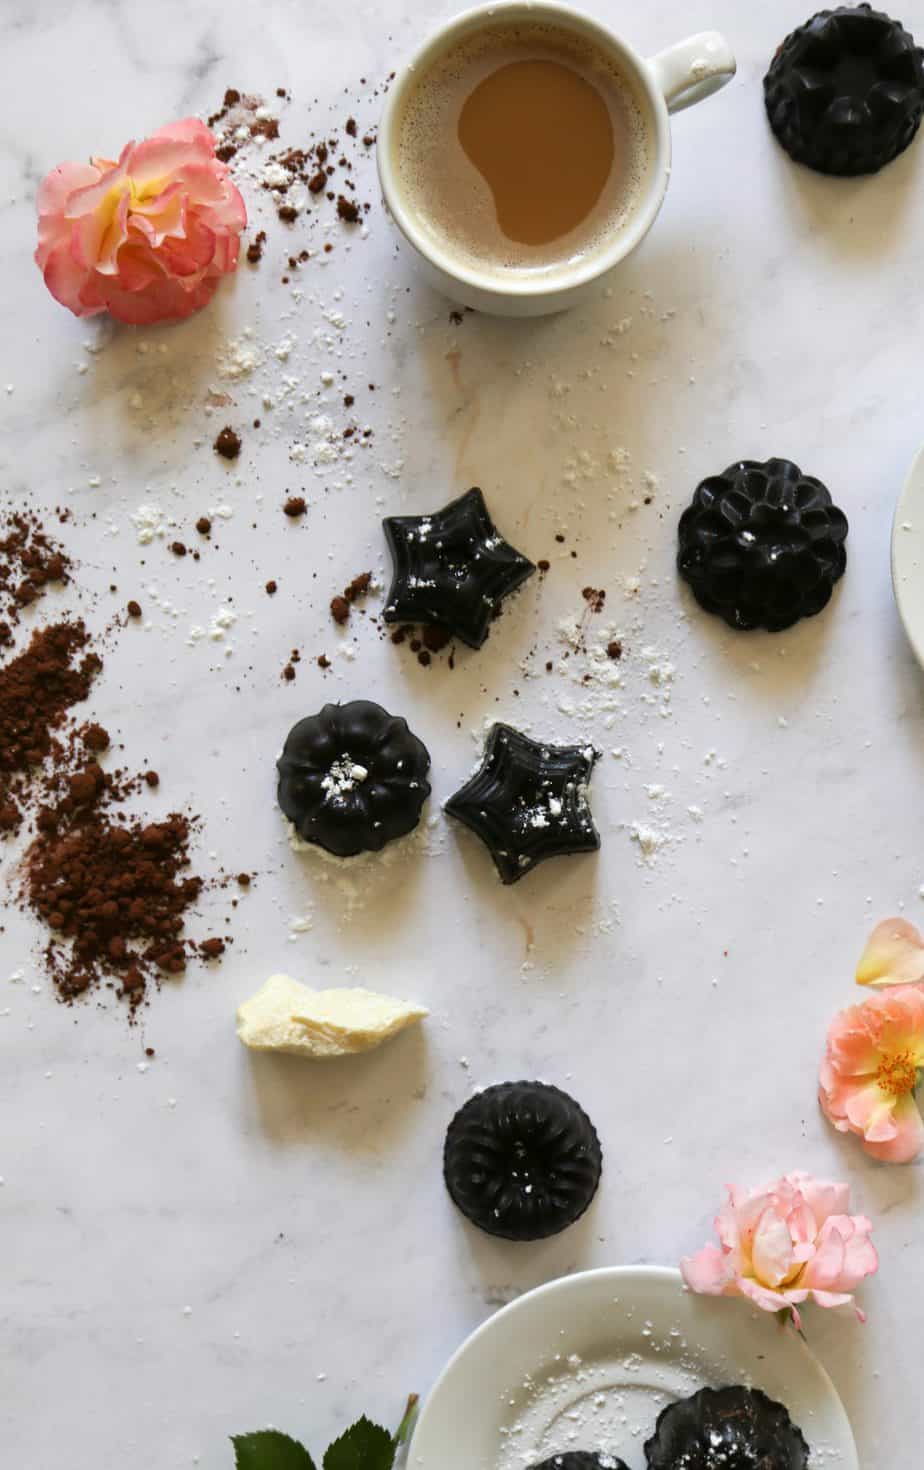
[680,1173,878,1327]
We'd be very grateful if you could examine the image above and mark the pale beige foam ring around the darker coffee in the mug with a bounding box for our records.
[392,22,651,279]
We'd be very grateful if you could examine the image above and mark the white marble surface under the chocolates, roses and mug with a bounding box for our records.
[0,0,924,1470]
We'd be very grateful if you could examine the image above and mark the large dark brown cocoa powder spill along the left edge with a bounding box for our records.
[0,517,237,1016]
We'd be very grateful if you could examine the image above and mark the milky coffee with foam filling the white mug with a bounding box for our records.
[392,18,651,276]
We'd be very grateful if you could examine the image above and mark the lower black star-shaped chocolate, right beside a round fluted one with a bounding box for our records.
[445,725,599,883]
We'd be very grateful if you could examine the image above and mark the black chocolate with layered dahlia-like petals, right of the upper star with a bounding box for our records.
[677,459,848,632]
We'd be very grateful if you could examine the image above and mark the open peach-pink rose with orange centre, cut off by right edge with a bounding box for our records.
[818,985,924,1164]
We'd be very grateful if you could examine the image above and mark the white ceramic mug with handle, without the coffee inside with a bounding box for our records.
[378,0,734,316]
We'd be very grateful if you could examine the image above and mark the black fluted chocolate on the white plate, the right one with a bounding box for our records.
[645,1385,809,1470]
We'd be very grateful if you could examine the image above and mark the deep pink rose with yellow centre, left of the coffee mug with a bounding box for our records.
[35,118,247,323]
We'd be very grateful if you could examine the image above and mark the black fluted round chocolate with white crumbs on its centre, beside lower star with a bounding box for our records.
[276,700,430,857]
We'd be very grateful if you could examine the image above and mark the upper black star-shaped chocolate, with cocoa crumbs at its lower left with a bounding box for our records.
[383,487,536,648]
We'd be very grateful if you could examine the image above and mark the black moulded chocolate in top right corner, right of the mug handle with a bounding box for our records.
[764,4,924,175]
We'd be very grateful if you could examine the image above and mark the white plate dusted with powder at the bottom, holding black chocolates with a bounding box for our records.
[408,1266,859,1470]
